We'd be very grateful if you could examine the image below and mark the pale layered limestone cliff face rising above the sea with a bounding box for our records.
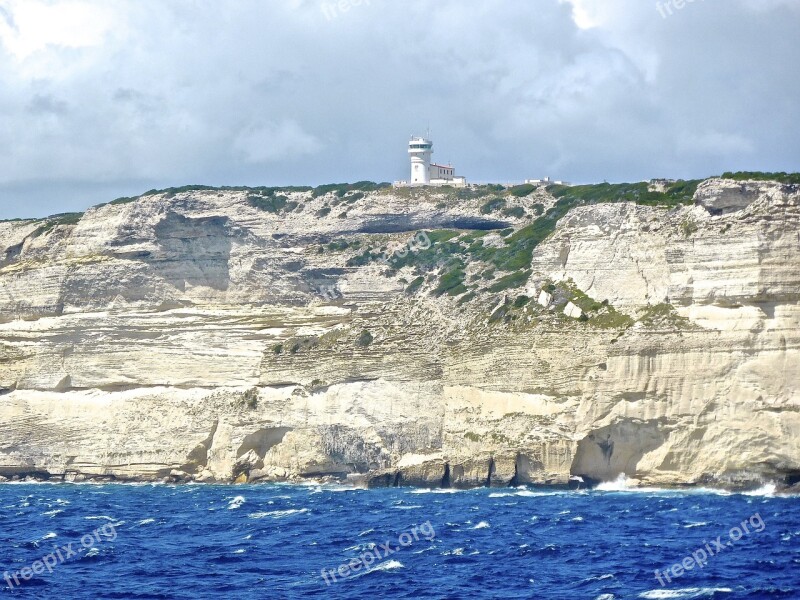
[0,180,800,487]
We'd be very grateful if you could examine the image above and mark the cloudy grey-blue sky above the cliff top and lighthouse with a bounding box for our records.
[0,0,800,219]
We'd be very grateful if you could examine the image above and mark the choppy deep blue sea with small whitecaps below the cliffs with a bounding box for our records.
[0,484,800,600]
